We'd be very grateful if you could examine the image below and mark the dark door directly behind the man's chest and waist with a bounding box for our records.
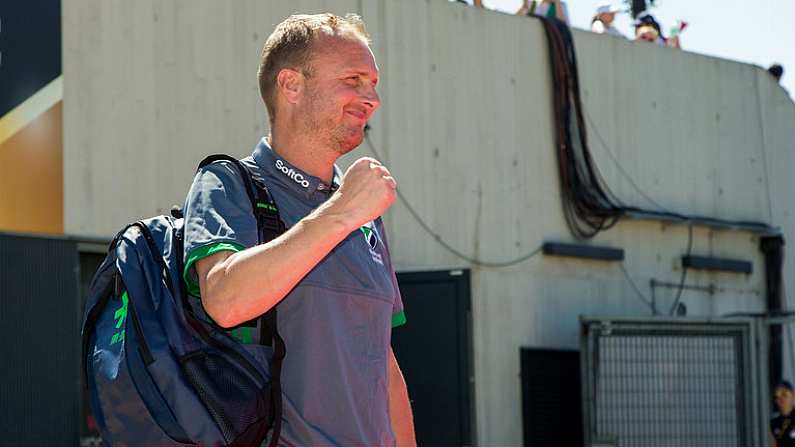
[392,270,473,447]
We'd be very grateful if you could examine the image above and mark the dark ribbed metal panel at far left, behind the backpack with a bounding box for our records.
[0,234,80,446]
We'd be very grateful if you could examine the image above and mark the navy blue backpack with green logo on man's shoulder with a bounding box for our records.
[82,155,286,447]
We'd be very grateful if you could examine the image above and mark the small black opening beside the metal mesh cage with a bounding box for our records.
[520,348,583,447]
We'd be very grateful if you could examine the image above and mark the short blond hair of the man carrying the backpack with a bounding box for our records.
[257,13,370,124]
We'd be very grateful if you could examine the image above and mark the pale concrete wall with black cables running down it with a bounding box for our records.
[63,0,795,446]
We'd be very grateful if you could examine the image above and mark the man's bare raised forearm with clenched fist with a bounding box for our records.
[195,158,395,327]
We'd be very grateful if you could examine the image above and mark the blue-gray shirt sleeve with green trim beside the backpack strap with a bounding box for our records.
[183,162,257,296]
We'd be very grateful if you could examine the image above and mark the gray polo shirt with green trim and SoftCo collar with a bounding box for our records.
[185,139,405,447]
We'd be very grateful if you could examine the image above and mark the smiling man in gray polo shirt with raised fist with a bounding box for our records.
[185,14,416,447]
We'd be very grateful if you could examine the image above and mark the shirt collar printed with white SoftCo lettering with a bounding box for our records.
[252,138,342,196]
